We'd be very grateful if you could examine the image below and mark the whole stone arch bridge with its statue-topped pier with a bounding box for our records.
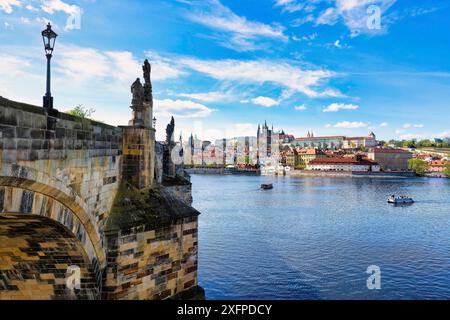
[0,60,199,299]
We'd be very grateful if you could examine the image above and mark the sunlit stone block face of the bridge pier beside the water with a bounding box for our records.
[103,217,198,300]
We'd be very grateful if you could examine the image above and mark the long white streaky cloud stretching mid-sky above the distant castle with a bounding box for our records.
[179,58,336,97]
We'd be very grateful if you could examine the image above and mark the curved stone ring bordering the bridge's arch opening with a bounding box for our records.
[0,164,106,272]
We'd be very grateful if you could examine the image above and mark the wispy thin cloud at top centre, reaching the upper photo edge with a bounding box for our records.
[187,0,288,51]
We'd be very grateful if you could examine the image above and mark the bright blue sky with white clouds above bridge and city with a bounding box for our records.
[0,0,450,139]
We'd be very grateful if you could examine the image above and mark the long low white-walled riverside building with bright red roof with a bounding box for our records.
[307,156,380,172]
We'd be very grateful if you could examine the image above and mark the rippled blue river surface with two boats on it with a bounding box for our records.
[192,175,450,299]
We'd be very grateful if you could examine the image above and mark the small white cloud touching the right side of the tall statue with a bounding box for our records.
[154,99,215,118]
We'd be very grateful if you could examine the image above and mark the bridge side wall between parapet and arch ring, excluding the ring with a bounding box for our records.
[0,98,122,227]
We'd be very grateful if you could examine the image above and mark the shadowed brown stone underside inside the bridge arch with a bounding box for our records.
[0,214,101,300]
